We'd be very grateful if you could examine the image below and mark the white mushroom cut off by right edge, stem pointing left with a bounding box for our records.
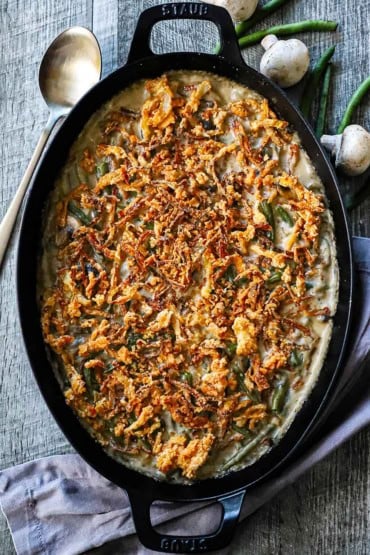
[321,125,370,175]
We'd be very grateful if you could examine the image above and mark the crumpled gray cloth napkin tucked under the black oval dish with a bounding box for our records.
[0,237,370,555]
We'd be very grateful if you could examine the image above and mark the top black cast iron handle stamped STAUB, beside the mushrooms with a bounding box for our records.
[127,2,243,64]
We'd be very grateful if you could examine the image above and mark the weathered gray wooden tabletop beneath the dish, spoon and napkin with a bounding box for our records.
[0,0,370,555]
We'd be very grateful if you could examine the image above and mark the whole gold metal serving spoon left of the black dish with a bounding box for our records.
[0,27,101,267]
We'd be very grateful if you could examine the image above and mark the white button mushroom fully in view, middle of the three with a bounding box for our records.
[260,35,310,88]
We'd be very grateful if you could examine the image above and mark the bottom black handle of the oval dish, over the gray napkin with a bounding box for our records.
[128,490,245,553]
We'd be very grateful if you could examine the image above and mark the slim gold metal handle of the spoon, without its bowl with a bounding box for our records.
[0,114,59,268]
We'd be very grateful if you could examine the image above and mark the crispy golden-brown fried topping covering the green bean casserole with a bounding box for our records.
[42,76,328,479]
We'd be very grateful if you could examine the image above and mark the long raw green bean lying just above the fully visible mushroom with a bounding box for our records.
[239,19,338,48]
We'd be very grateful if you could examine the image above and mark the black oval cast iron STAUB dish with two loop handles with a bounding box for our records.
[17,3,352,553]
